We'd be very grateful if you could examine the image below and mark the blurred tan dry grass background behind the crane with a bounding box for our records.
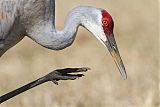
[0,0,160,107]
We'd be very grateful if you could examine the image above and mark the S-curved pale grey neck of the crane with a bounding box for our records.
[28,8,83,50]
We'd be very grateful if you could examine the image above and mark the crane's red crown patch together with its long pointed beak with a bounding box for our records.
[100,10,127,79]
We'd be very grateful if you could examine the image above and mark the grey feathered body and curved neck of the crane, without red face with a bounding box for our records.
[0,0,102,56]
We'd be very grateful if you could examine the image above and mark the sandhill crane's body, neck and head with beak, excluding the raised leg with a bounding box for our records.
[0,0,127,103]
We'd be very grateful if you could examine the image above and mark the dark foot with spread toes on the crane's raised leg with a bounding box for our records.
[45,67,90,85]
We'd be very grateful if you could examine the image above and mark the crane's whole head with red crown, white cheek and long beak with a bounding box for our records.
[82,7,127,79]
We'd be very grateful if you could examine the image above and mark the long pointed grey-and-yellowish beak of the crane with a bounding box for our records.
[104,34,127,79]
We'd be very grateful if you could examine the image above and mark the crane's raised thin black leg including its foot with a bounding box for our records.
[0,67,90,104]
